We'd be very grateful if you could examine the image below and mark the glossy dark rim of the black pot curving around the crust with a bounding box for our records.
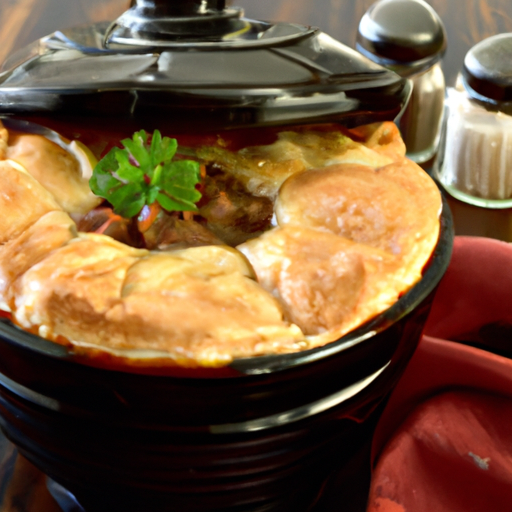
[0,197,454,378]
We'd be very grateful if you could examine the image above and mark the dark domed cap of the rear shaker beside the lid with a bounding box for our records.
[357,0,446,75]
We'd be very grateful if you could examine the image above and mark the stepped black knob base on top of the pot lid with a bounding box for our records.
[104,0,247,48]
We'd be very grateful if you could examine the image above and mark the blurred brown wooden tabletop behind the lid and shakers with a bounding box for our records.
[0,0,512,84]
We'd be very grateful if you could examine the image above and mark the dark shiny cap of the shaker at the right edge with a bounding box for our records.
[462,33,512,113]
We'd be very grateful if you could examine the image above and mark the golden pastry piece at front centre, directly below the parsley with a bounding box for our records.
[108,247,304,366]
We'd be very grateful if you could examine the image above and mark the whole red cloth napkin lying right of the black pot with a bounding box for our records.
[368,237,512,512]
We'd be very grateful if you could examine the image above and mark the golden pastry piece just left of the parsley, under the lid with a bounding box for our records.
[6,132,102,216]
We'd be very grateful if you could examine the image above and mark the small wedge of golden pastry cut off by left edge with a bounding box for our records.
[0,160,61,244]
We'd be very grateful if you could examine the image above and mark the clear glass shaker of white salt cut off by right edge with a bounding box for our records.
[434,33,512,242]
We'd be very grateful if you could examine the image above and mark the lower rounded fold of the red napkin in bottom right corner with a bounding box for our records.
[368,392,512,512]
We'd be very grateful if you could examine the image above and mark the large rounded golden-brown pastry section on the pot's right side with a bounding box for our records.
[238,154,441,346]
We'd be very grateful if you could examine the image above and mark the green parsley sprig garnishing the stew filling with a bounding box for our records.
[89,130,201,218]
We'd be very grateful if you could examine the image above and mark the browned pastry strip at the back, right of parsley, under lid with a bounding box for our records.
[198,123,396,199]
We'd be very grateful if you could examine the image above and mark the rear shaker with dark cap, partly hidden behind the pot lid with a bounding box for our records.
[356,0,446,164]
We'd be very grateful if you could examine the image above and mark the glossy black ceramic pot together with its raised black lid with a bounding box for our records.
[0,0,453,512]
